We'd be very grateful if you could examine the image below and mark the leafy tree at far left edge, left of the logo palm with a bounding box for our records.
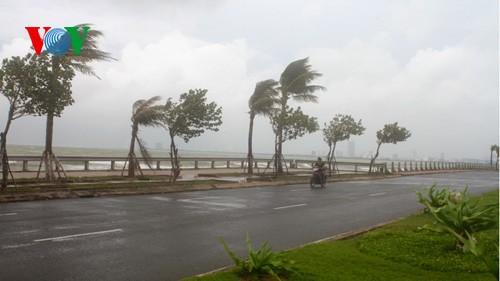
[0,54,35,189]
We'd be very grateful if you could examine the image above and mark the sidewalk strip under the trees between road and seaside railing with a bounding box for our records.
[0,168,468,203]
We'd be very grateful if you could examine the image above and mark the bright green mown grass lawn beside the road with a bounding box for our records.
[187,191,499,281]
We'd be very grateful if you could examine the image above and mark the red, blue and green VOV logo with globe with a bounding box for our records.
[25,26,90,56]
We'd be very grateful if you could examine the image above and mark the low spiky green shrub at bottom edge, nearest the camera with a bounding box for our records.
[220,233,295,280]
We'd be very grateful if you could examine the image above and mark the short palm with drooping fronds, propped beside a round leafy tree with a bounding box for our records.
[127,96,163,177]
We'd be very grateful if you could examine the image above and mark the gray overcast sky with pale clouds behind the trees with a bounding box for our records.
[0,0,499,159]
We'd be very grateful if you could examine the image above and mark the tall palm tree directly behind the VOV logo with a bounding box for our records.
[43,24,114,180]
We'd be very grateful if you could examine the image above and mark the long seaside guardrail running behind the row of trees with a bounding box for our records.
[9,156,493,173]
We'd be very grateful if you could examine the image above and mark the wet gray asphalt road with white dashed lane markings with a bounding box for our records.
[0,172,499,281]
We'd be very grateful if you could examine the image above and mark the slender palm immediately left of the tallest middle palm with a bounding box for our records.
[247,79,278,174]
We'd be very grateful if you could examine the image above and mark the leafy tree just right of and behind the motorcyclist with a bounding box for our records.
[323,114,365,175]
